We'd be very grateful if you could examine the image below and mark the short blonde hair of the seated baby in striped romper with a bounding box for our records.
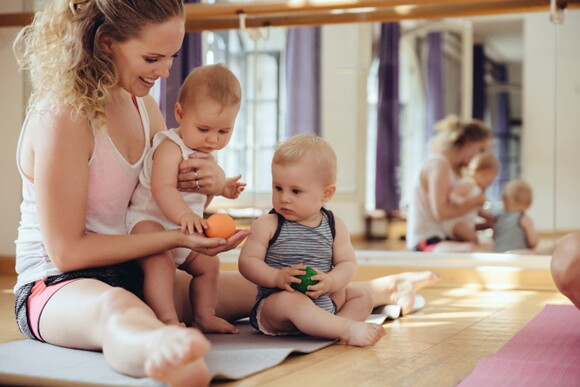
[272,134,337,184]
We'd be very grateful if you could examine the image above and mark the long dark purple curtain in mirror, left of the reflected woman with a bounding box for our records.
[375,23,400,211]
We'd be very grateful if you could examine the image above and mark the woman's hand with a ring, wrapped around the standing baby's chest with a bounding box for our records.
[177,152,226,195]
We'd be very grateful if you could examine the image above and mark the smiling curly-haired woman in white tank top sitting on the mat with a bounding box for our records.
[15,0,436,386]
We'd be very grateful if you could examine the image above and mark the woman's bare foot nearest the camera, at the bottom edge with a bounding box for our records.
[145,326,211,387]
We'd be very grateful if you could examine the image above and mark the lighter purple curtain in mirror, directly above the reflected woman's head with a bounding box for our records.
[425,32,445,140]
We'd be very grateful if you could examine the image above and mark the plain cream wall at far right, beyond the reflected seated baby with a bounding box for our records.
[522,11,580,231]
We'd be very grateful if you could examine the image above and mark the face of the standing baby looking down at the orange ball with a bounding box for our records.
[179,99,240,153]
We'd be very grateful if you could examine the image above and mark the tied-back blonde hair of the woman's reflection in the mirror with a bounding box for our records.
[431,115,491,152]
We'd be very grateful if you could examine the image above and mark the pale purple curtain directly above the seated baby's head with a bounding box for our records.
[286,27,321,137]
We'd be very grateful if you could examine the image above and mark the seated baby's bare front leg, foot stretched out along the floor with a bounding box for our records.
[258,291,385,347]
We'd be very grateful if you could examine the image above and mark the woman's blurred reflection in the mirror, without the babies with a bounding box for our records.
[407,116,491,251]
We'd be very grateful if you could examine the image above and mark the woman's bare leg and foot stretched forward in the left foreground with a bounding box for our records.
[40,279,210,386]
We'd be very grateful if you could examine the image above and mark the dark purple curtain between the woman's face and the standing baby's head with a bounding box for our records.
[159,0,203,128]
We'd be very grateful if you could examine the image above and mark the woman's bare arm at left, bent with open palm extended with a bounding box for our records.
[28,110,227,271]
